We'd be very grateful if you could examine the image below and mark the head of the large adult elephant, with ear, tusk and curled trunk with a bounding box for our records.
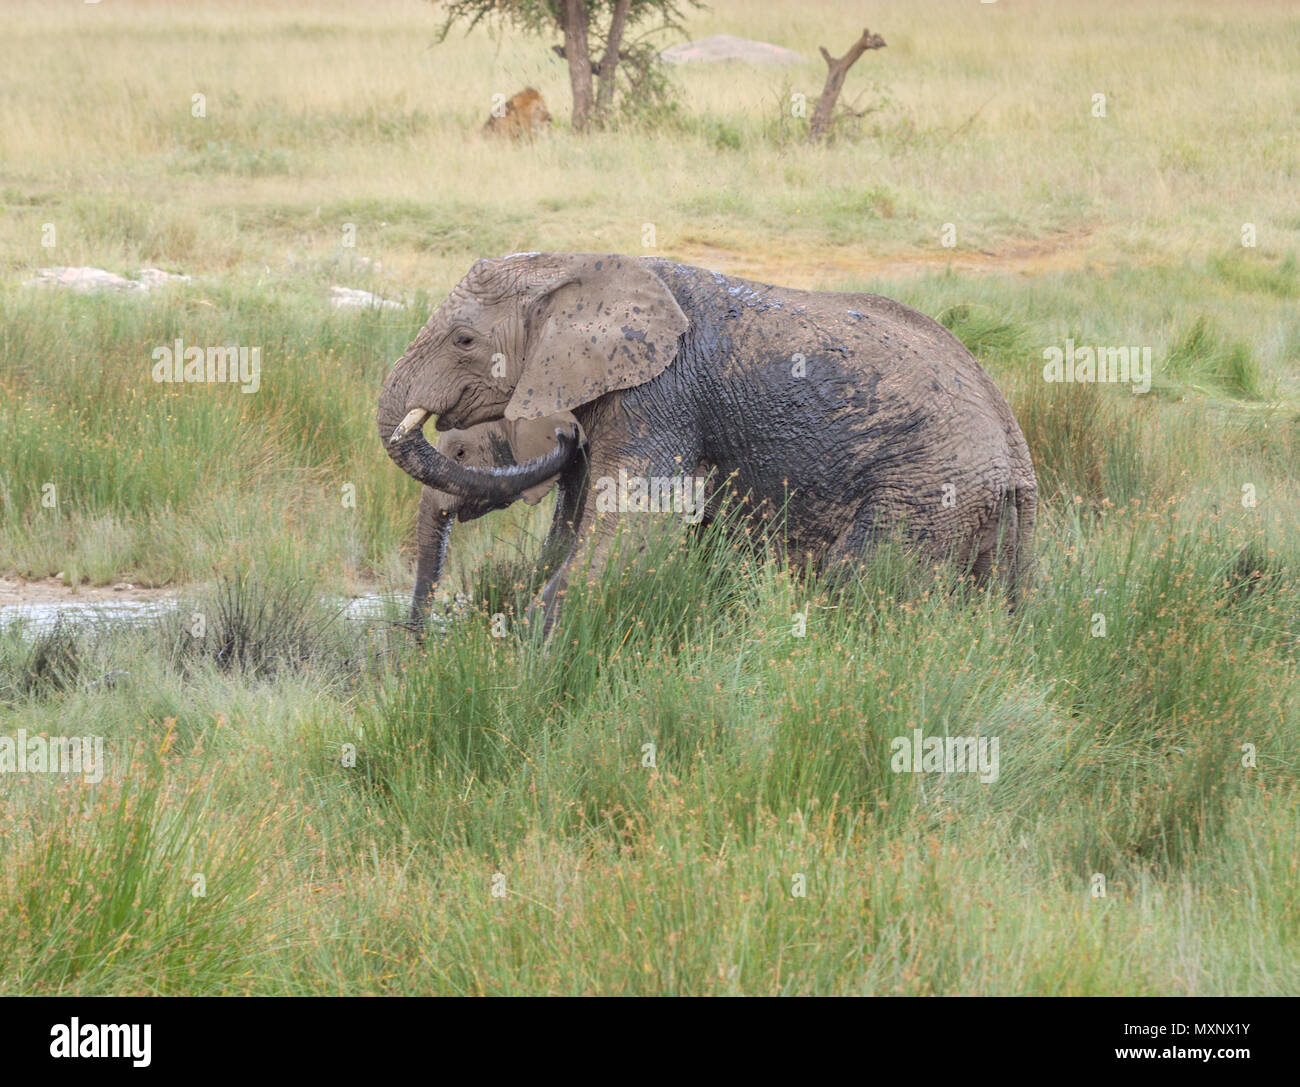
[378,254,686,491]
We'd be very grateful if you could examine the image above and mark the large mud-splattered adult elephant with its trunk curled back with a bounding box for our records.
[378,254,1037,628]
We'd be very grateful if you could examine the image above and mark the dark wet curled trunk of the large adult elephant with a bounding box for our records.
[378,384,579,506]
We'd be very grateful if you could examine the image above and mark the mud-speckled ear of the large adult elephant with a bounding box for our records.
[506,254,688,419]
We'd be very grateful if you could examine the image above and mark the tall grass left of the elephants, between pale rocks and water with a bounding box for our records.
[0,283,420,584]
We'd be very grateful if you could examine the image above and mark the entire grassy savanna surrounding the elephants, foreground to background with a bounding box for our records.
[0,0,1300,995]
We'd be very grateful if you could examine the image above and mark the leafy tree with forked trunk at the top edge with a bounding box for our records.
[433,0,703,133]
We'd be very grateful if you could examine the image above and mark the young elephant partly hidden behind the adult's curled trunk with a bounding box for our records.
[410,412,581,631]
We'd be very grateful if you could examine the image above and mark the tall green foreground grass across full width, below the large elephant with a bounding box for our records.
[0,491,1300,995]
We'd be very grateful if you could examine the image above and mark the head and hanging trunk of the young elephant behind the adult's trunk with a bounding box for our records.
[411,412,582,627]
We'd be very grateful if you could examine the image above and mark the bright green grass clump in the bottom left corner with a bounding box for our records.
[0,731,283,995]
